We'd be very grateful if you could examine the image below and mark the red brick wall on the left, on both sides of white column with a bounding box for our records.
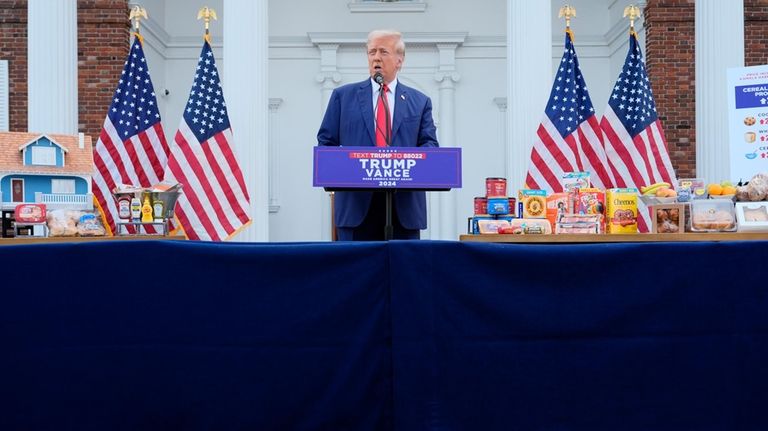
[0,0,130,142]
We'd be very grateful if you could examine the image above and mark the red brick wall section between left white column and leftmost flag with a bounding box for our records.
[77,0,130,143]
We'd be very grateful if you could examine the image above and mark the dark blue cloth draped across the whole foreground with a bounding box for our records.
[0,241,768,431]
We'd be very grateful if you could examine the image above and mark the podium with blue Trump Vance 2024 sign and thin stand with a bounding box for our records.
[312,146,461,240]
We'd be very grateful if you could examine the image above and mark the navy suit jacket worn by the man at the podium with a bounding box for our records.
[317,79,438,229]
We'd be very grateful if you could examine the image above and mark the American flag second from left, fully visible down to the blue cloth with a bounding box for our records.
[166,39,251,241]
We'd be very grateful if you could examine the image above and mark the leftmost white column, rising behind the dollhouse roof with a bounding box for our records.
[27,0,78,135]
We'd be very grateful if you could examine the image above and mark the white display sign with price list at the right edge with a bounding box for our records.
[728,65,768,181]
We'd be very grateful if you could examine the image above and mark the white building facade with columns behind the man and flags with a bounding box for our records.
[30,0,744,242]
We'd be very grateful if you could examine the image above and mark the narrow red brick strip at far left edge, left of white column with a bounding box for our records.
[0,0,27,132]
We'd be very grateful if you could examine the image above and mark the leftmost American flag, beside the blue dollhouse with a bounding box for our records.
[93,36,170,234]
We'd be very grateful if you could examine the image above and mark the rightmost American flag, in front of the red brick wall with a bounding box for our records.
[600,31,677,232]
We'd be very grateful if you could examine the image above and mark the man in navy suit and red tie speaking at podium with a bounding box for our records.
[317,30,438,241]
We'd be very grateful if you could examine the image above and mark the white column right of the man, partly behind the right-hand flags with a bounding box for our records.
[506,0,552,196]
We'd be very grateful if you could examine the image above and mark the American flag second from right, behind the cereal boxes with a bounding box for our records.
[525,30,613,192]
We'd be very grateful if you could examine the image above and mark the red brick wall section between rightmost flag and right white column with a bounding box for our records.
[644,0,696,178]
